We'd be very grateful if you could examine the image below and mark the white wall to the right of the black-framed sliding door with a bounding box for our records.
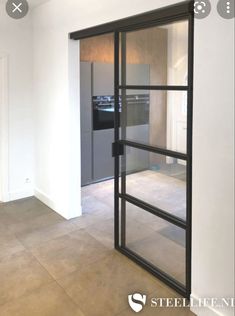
[192,4,234,316]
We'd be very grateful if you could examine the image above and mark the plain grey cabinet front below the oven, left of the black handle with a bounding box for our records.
[93,129,114,180]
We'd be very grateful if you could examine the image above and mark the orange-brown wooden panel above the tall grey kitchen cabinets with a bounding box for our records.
[80,28,167,69]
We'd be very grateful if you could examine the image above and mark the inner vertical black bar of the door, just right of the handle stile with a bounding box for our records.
[121,32,127,247]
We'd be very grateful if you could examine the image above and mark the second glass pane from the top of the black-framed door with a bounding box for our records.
[120,90,187,153]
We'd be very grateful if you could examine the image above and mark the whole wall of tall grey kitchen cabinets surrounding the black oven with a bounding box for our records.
[80,62,150,185]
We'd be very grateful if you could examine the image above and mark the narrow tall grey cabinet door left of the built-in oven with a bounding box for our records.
[80,62,93,185]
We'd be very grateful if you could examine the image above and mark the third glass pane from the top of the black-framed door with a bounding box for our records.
[121,146,187,220]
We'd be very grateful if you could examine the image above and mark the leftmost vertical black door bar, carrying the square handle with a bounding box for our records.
[114,32,119,249]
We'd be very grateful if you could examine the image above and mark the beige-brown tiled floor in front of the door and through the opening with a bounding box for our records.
[0,177,193,316]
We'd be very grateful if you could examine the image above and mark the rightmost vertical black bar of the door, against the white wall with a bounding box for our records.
[186,13,194,298]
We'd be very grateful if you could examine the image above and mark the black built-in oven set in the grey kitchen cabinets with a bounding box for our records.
[92,94,149,130]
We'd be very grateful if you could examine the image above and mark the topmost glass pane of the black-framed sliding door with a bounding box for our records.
[121,21,188,85]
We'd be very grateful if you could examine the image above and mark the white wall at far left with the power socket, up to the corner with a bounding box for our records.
[0,4,34,201]
